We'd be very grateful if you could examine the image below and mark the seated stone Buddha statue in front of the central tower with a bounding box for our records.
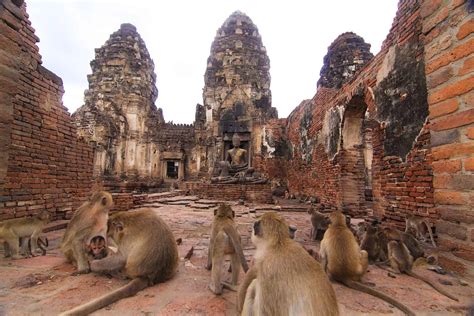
[211,134,267,184]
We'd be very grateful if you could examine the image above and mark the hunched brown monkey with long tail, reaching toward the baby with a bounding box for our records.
[62,209,179,315]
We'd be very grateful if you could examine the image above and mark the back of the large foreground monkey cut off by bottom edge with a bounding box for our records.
[257,240,339,315]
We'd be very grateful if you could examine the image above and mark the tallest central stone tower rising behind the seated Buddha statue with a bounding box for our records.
[196,11,278,175]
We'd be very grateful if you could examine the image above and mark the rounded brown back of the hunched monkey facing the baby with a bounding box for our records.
[114,209,179,283]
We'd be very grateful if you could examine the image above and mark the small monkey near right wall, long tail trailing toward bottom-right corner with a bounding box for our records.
[388,233,459,301]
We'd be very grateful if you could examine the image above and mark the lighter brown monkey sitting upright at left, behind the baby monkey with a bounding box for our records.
[61,191,113,274]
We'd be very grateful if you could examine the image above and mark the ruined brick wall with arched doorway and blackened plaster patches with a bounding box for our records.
[262,0,439,227]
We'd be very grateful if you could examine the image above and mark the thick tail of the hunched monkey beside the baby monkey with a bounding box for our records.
[60,278,148,316]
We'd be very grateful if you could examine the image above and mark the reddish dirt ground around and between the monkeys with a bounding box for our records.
[0,197,474,315]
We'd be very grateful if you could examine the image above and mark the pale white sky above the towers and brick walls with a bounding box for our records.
[26,0,398,123]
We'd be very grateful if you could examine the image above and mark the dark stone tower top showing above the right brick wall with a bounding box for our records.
[318,32,374,89]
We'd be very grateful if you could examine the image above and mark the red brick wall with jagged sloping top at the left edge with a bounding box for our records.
[0,0,93,220]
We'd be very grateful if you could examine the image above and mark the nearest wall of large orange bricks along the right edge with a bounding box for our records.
[421,0,474,275]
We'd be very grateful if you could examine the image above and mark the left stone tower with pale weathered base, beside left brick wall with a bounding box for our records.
[73,24,163,179]
